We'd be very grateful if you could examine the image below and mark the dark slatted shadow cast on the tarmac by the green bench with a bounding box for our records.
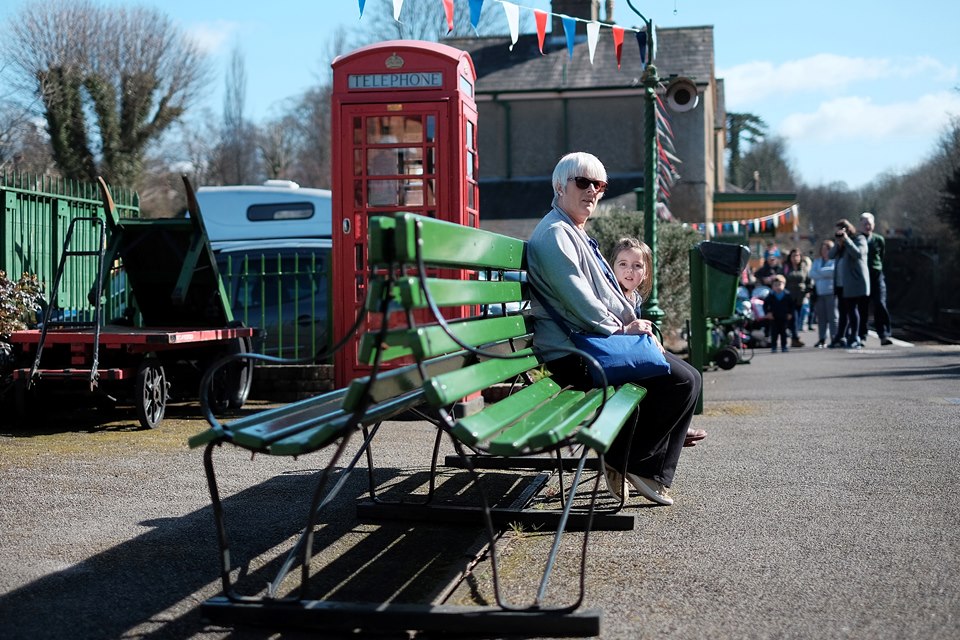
[0,460,530,638]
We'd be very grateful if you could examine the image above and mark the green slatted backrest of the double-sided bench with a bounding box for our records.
[345,214,539,410]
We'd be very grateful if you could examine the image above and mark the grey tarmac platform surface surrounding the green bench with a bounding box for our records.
[0,332,960,640]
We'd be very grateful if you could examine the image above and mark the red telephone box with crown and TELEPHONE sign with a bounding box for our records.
[332,40,479,387]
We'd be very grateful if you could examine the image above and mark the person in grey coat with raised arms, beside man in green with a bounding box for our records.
[829,218,870,349]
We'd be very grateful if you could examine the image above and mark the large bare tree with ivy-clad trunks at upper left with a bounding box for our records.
[2,0,209,185]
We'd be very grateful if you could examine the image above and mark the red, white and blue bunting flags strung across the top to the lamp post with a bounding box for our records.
[358,0,656,69]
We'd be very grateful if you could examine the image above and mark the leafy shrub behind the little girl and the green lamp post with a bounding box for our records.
[588,209,703,342]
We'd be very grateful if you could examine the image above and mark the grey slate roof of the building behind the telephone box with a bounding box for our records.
[444,26,714,94]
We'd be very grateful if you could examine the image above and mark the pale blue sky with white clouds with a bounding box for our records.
[0,0,960,189]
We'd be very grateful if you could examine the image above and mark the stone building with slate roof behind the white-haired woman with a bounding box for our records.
[445,0,726,237]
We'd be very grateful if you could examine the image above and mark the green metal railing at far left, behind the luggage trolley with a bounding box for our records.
[0,173,140,319]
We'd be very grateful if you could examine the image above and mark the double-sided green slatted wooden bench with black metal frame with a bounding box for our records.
[190,214,646,635]
